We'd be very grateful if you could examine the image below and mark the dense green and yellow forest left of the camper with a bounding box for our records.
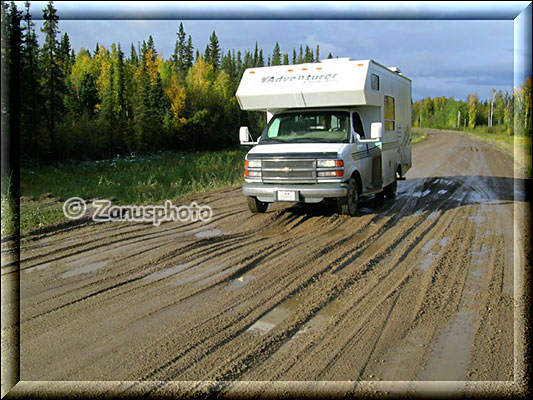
[1,1,333,161]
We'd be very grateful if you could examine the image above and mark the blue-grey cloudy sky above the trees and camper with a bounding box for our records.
[17,2,524,101]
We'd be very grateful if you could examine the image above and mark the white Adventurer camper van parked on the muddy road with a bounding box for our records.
[236,58,411,215]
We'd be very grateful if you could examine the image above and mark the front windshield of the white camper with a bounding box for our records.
[261,111,350,143]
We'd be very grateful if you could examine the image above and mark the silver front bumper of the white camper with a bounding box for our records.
[242,182,348,203]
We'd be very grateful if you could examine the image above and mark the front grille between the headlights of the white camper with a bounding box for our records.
[262,159,316,183]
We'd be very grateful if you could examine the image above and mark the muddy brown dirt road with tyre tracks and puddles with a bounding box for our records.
[2,133,530,396]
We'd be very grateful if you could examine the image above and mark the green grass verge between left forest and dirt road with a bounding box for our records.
[2,149,248,236]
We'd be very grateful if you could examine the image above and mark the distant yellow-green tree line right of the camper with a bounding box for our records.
[412,77,531,135]
